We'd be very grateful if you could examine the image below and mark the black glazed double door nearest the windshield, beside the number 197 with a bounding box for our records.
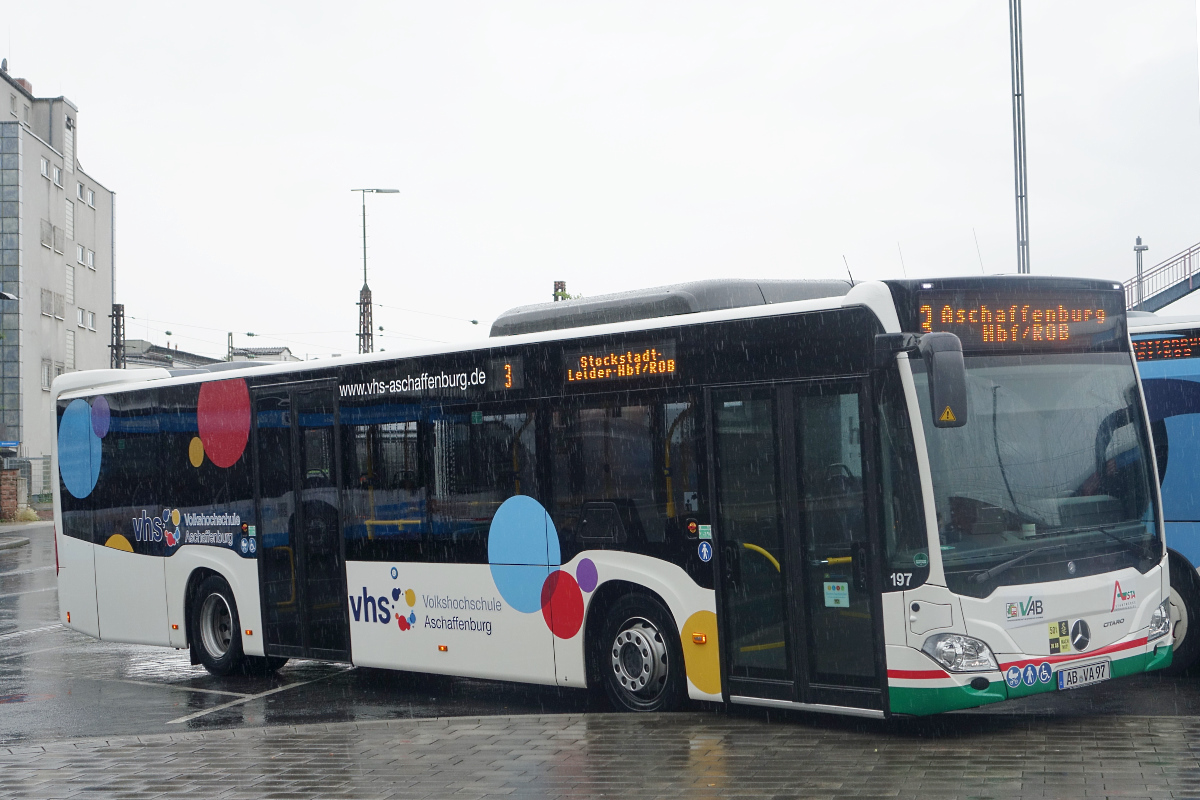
[709,381,882,714]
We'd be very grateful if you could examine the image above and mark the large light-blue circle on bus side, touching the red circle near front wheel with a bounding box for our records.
[487,494,562,614]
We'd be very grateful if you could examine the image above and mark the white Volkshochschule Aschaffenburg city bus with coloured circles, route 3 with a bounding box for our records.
[53,277,1171,716]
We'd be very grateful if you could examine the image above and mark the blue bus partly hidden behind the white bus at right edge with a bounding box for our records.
[1129,312,1200,674]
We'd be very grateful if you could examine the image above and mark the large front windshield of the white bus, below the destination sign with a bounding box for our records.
[912,353,1162,597]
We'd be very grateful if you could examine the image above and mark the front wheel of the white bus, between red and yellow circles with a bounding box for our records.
[599,594,686,711]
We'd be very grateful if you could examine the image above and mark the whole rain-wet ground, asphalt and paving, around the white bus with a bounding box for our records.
[7,523,1200,798]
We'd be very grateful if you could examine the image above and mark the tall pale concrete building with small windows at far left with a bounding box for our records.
[0,62,114,457]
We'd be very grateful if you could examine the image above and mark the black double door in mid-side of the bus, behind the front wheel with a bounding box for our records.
[254,384,350,661]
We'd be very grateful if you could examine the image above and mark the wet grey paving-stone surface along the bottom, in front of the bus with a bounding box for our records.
[0,711,1200,799]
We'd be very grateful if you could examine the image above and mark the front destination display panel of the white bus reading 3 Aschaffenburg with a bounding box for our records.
[917,291,1121,349]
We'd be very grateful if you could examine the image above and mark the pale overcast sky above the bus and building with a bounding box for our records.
[0,0,1200,357]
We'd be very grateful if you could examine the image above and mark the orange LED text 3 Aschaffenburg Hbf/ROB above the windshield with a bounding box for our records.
[920,305,1108,342]
